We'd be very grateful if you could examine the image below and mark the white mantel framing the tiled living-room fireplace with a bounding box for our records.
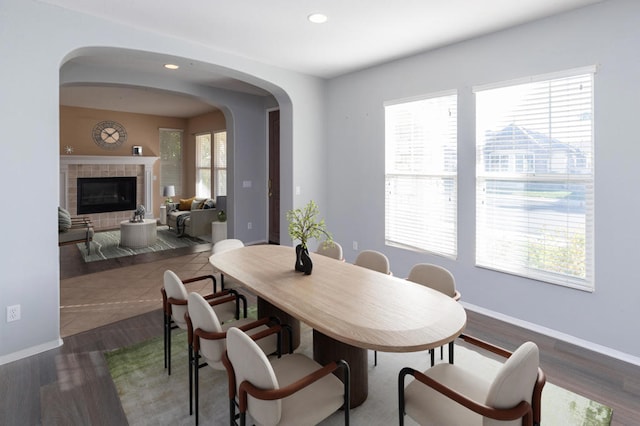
[60,155,160,218]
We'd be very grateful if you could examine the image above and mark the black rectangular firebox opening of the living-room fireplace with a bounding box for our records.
[78,176,136,214]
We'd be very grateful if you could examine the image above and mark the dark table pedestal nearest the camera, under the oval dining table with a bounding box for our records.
[313,329,369,408]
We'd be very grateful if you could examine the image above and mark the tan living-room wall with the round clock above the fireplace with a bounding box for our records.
[60,106,226,220]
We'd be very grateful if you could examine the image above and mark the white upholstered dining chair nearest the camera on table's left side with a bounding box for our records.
[223,327,350,426]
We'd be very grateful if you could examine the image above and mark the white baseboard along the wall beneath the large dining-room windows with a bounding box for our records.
[460,301,640,367]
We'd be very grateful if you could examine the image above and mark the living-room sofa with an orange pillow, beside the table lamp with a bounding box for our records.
[167,196,227,237]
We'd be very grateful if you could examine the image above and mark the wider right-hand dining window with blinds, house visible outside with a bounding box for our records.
[474,68,595,291]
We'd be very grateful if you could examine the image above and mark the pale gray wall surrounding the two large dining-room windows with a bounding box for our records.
[327,0,640,357]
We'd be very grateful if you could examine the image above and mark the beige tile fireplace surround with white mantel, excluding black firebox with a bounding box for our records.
[60,155,158,230]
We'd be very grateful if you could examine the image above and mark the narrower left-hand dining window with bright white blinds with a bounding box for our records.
[385,92,458,257]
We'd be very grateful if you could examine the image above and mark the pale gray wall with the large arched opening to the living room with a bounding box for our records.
[0,0,326,364]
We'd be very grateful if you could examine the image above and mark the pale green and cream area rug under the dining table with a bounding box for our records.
[105,324,612,426]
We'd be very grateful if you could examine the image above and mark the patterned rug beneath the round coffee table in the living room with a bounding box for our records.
[77,226,207,262]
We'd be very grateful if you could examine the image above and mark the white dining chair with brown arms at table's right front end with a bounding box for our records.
[398,335,546,426]
